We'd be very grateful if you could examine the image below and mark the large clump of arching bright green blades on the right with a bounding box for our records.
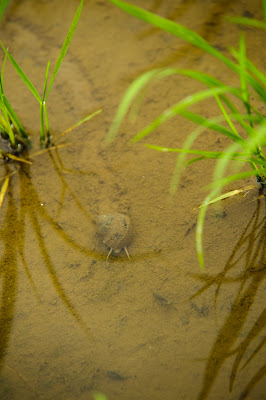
[106,0,266,267]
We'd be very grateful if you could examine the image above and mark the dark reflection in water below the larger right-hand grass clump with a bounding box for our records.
[193,192,266,399]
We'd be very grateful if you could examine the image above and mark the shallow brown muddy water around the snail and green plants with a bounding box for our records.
[0,0,266,400]
